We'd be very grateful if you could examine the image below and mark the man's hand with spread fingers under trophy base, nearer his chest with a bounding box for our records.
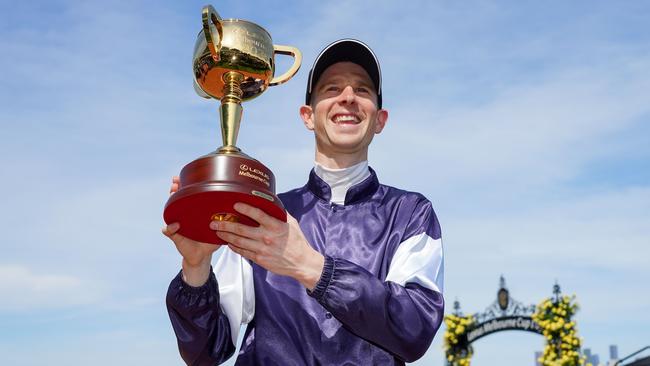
[210,203,325,290]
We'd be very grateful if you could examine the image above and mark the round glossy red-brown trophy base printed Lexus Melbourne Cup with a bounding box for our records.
[163,152,287,244]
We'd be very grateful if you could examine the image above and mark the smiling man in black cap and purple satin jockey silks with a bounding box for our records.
[163,39,443,365]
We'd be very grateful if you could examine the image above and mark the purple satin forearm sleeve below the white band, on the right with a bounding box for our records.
[310,256,444,362]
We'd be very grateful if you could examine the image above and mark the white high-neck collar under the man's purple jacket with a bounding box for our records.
[314,160,370,205]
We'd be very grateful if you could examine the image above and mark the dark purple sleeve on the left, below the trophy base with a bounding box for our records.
[167,270,235,366]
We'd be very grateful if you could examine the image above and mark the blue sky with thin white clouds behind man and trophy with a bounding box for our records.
[0,0,650,366]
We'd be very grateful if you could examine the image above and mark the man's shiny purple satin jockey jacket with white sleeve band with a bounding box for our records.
[167,169,444,366]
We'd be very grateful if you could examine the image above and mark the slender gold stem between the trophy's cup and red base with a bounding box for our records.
[219,71,244,153]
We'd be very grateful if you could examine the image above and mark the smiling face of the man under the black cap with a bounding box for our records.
[300,62,388,168]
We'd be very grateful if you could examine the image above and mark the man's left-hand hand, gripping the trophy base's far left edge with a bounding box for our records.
[162,177,221,287]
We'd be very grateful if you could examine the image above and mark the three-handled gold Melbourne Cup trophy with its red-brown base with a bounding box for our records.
[163,5,302,244]
